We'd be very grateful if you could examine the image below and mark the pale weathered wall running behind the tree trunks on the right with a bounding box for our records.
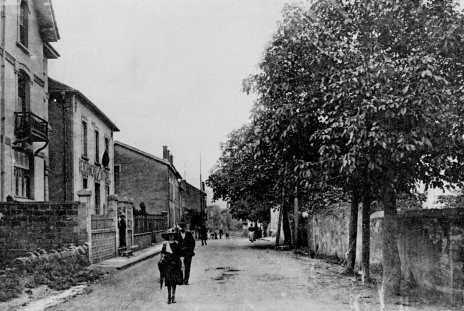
[307,205,464,299]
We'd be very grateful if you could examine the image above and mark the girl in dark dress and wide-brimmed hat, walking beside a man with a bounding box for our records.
[158,231,183,304]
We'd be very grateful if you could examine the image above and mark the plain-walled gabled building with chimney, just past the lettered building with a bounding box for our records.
[114,141,182,226]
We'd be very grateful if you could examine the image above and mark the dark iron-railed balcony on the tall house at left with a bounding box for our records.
[15,112,48,142]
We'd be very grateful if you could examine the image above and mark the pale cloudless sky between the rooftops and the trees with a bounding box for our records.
[49,0,294,202]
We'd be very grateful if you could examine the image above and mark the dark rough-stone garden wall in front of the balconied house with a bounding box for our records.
[0,202,87,266]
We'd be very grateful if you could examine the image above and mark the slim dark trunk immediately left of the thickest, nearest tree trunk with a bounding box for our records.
[361,194,371,283]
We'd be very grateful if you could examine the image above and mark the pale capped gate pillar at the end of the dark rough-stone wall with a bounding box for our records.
[77,190,92,264]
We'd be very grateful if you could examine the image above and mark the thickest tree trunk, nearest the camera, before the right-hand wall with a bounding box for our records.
[382,184,401,297]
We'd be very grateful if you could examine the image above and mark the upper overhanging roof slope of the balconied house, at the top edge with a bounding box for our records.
[34,0,60,42]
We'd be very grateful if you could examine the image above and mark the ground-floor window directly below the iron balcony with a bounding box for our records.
[14,150,32,199]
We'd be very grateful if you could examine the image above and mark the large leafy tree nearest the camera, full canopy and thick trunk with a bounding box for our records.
[245,0,464,294]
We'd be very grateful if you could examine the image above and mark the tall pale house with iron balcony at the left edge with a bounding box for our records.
[0,0,60,201]
